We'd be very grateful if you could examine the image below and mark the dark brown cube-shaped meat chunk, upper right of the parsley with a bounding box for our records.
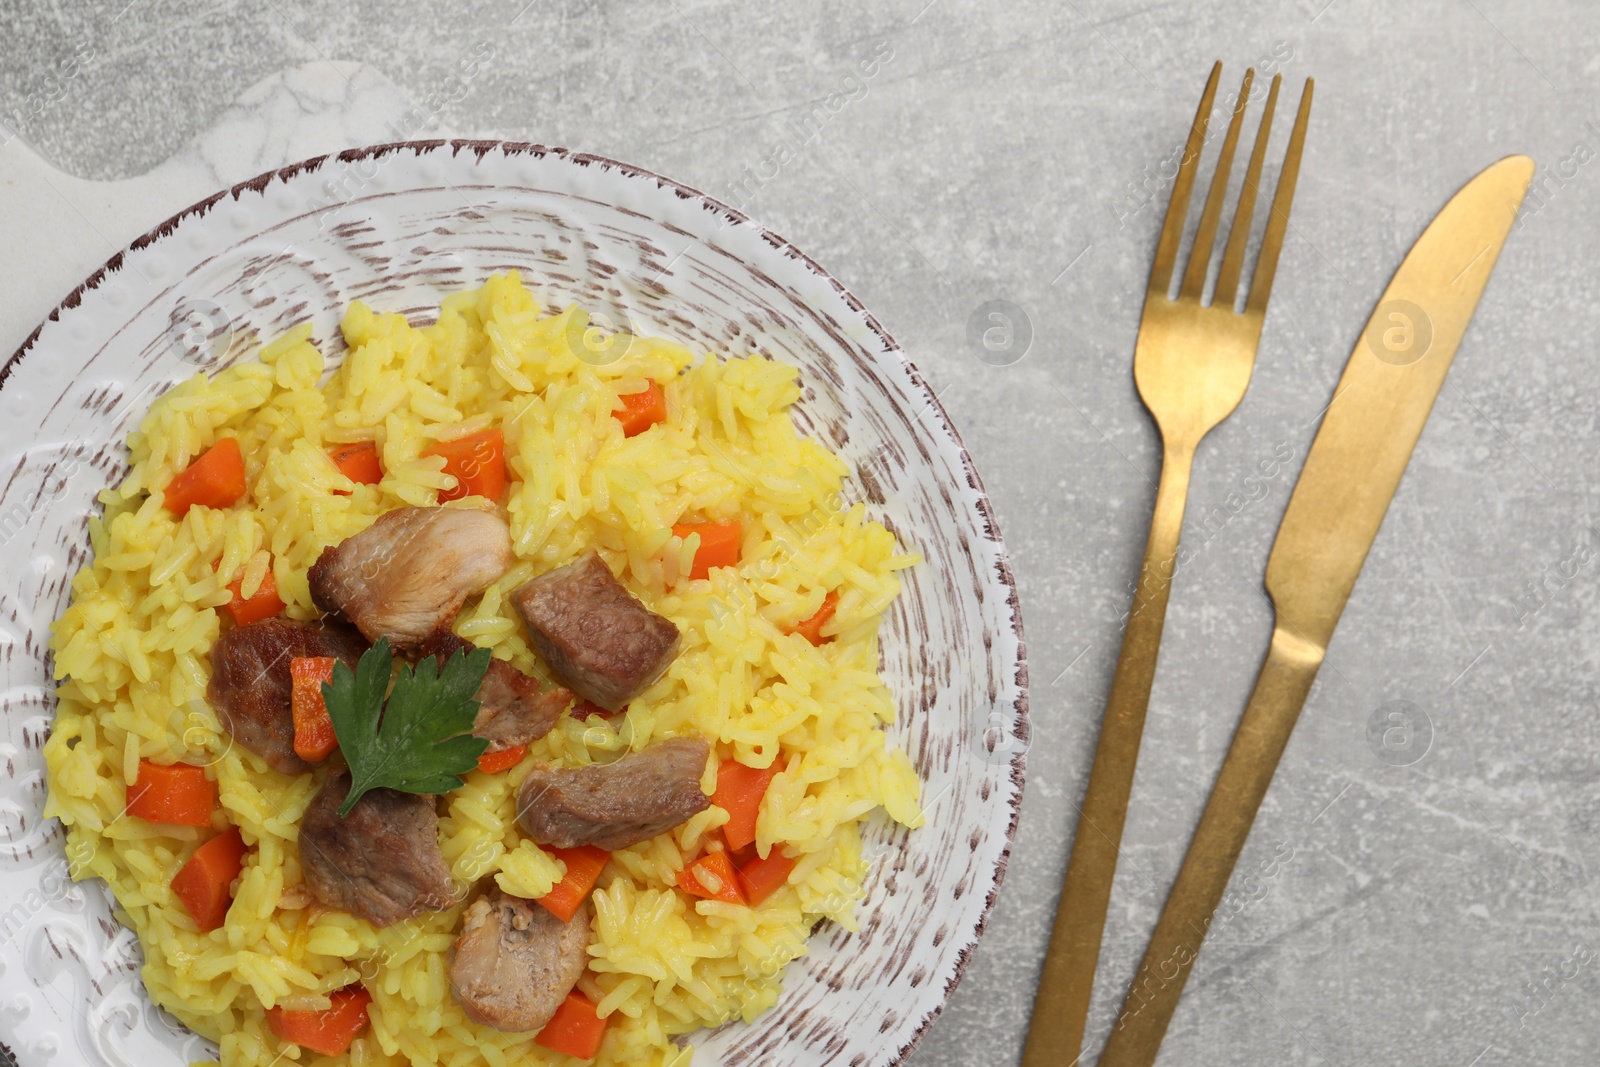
[510,552,678,712]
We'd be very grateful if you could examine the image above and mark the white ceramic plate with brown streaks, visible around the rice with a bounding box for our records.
[0,142,1029,1067]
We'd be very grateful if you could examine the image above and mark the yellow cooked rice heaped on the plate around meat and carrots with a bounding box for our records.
[45,272,922,1067]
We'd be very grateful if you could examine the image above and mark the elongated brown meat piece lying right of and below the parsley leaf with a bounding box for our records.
[517,737,710,853]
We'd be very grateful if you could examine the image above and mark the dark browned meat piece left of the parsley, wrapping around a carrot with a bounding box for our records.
[206,619,366,774]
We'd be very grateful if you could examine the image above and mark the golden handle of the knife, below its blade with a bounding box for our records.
[1099,616,1323,1067]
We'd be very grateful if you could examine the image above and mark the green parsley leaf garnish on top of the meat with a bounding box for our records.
[322,637,490,816]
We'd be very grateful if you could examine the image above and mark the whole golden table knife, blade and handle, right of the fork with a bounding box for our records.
[1099,155,1534,1067]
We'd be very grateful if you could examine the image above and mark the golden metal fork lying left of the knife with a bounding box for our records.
[1022,62,1312,1067]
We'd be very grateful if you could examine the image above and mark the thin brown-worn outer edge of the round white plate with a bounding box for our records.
[0,138,1032,1067]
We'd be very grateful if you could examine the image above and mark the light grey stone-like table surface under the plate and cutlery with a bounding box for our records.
[0,0,1600,1067]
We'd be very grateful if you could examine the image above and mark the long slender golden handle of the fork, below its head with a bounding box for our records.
[1022,445,1194,1067]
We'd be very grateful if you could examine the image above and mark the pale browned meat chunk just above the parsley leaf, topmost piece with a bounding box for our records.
[307,507,517,651]
